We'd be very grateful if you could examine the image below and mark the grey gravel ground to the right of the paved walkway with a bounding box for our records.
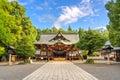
[74,63,120,80]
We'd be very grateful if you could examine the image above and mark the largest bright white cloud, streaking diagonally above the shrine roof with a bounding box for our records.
[54,0,94,28]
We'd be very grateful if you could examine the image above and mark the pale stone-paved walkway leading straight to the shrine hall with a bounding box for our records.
[23,62,98,80]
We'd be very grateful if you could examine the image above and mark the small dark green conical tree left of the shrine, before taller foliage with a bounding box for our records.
[16,36,35,62]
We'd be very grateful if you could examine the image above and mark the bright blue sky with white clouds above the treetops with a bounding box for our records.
[9,0,109,29]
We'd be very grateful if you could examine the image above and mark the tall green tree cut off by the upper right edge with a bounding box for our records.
[105,0,120,46]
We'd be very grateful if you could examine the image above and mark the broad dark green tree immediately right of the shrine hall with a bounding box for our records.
[77,29,107,55]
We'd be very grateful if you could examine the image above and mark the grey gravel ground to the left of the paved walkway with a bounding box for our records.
[0,63,44,80]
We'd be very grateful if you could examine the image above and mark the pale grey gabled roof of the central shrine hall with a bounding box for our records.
[34,32,79,45]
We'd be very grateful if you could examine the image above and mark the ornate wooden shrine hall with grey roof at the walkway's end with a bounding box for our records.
[34,32,82,61]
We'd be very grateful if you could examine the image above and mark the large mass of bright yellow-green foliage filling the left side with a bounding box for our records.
[0,0,37,58]
